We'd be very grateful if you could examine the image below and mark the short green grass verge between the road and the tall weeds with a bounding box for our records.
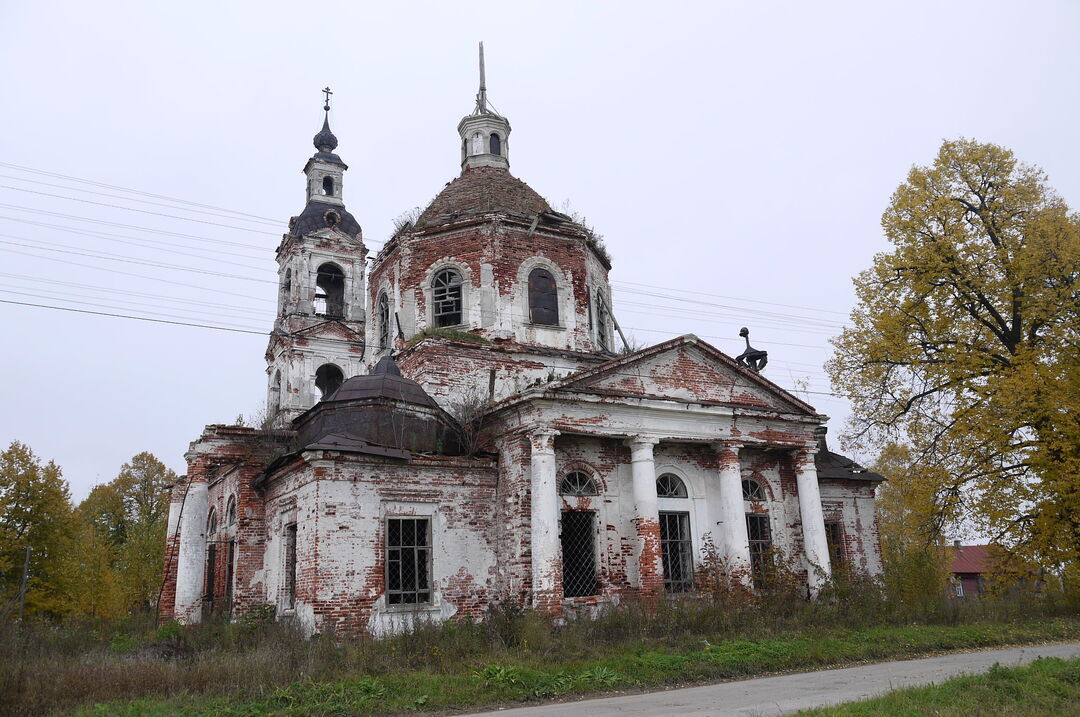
[67,618,1080,716]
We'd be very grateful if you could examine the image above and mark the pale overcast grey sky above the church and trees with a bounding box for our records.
[0,0,1080,499]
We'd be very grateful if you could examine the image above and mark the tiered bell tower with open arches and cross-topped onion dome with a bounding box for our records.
[266,87,367,427]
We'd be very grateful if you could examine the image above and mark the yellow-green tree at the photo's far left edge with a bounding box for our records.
[0,441,71,615]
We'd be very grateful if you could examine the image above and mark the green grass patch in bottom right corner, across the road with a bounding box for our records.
[798,658,1080,717]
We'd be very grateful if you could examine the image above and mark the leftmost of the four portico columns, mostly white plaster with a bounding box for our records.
[529,430,563,607]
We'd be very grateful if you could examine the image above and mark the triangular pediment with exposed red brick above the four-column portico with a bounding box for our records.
[549,335,816,415]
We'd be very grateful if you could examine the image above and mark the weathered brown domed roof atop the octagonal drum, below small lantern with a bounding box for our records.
[416,166,552,228]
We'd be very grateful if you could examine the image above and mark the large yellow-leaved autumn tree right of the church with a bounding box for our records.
[826,139,1080,567]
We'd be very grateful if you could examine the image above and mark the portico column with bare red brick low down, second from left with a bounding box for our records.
[626,436,664,593]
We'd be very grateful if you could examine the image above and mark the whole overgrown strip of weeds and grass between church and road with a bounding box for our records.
[0,578,1080,715]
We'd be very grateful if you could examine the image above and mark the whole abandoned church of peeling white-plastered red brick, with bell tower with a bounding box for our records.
[161,51,881,635]
